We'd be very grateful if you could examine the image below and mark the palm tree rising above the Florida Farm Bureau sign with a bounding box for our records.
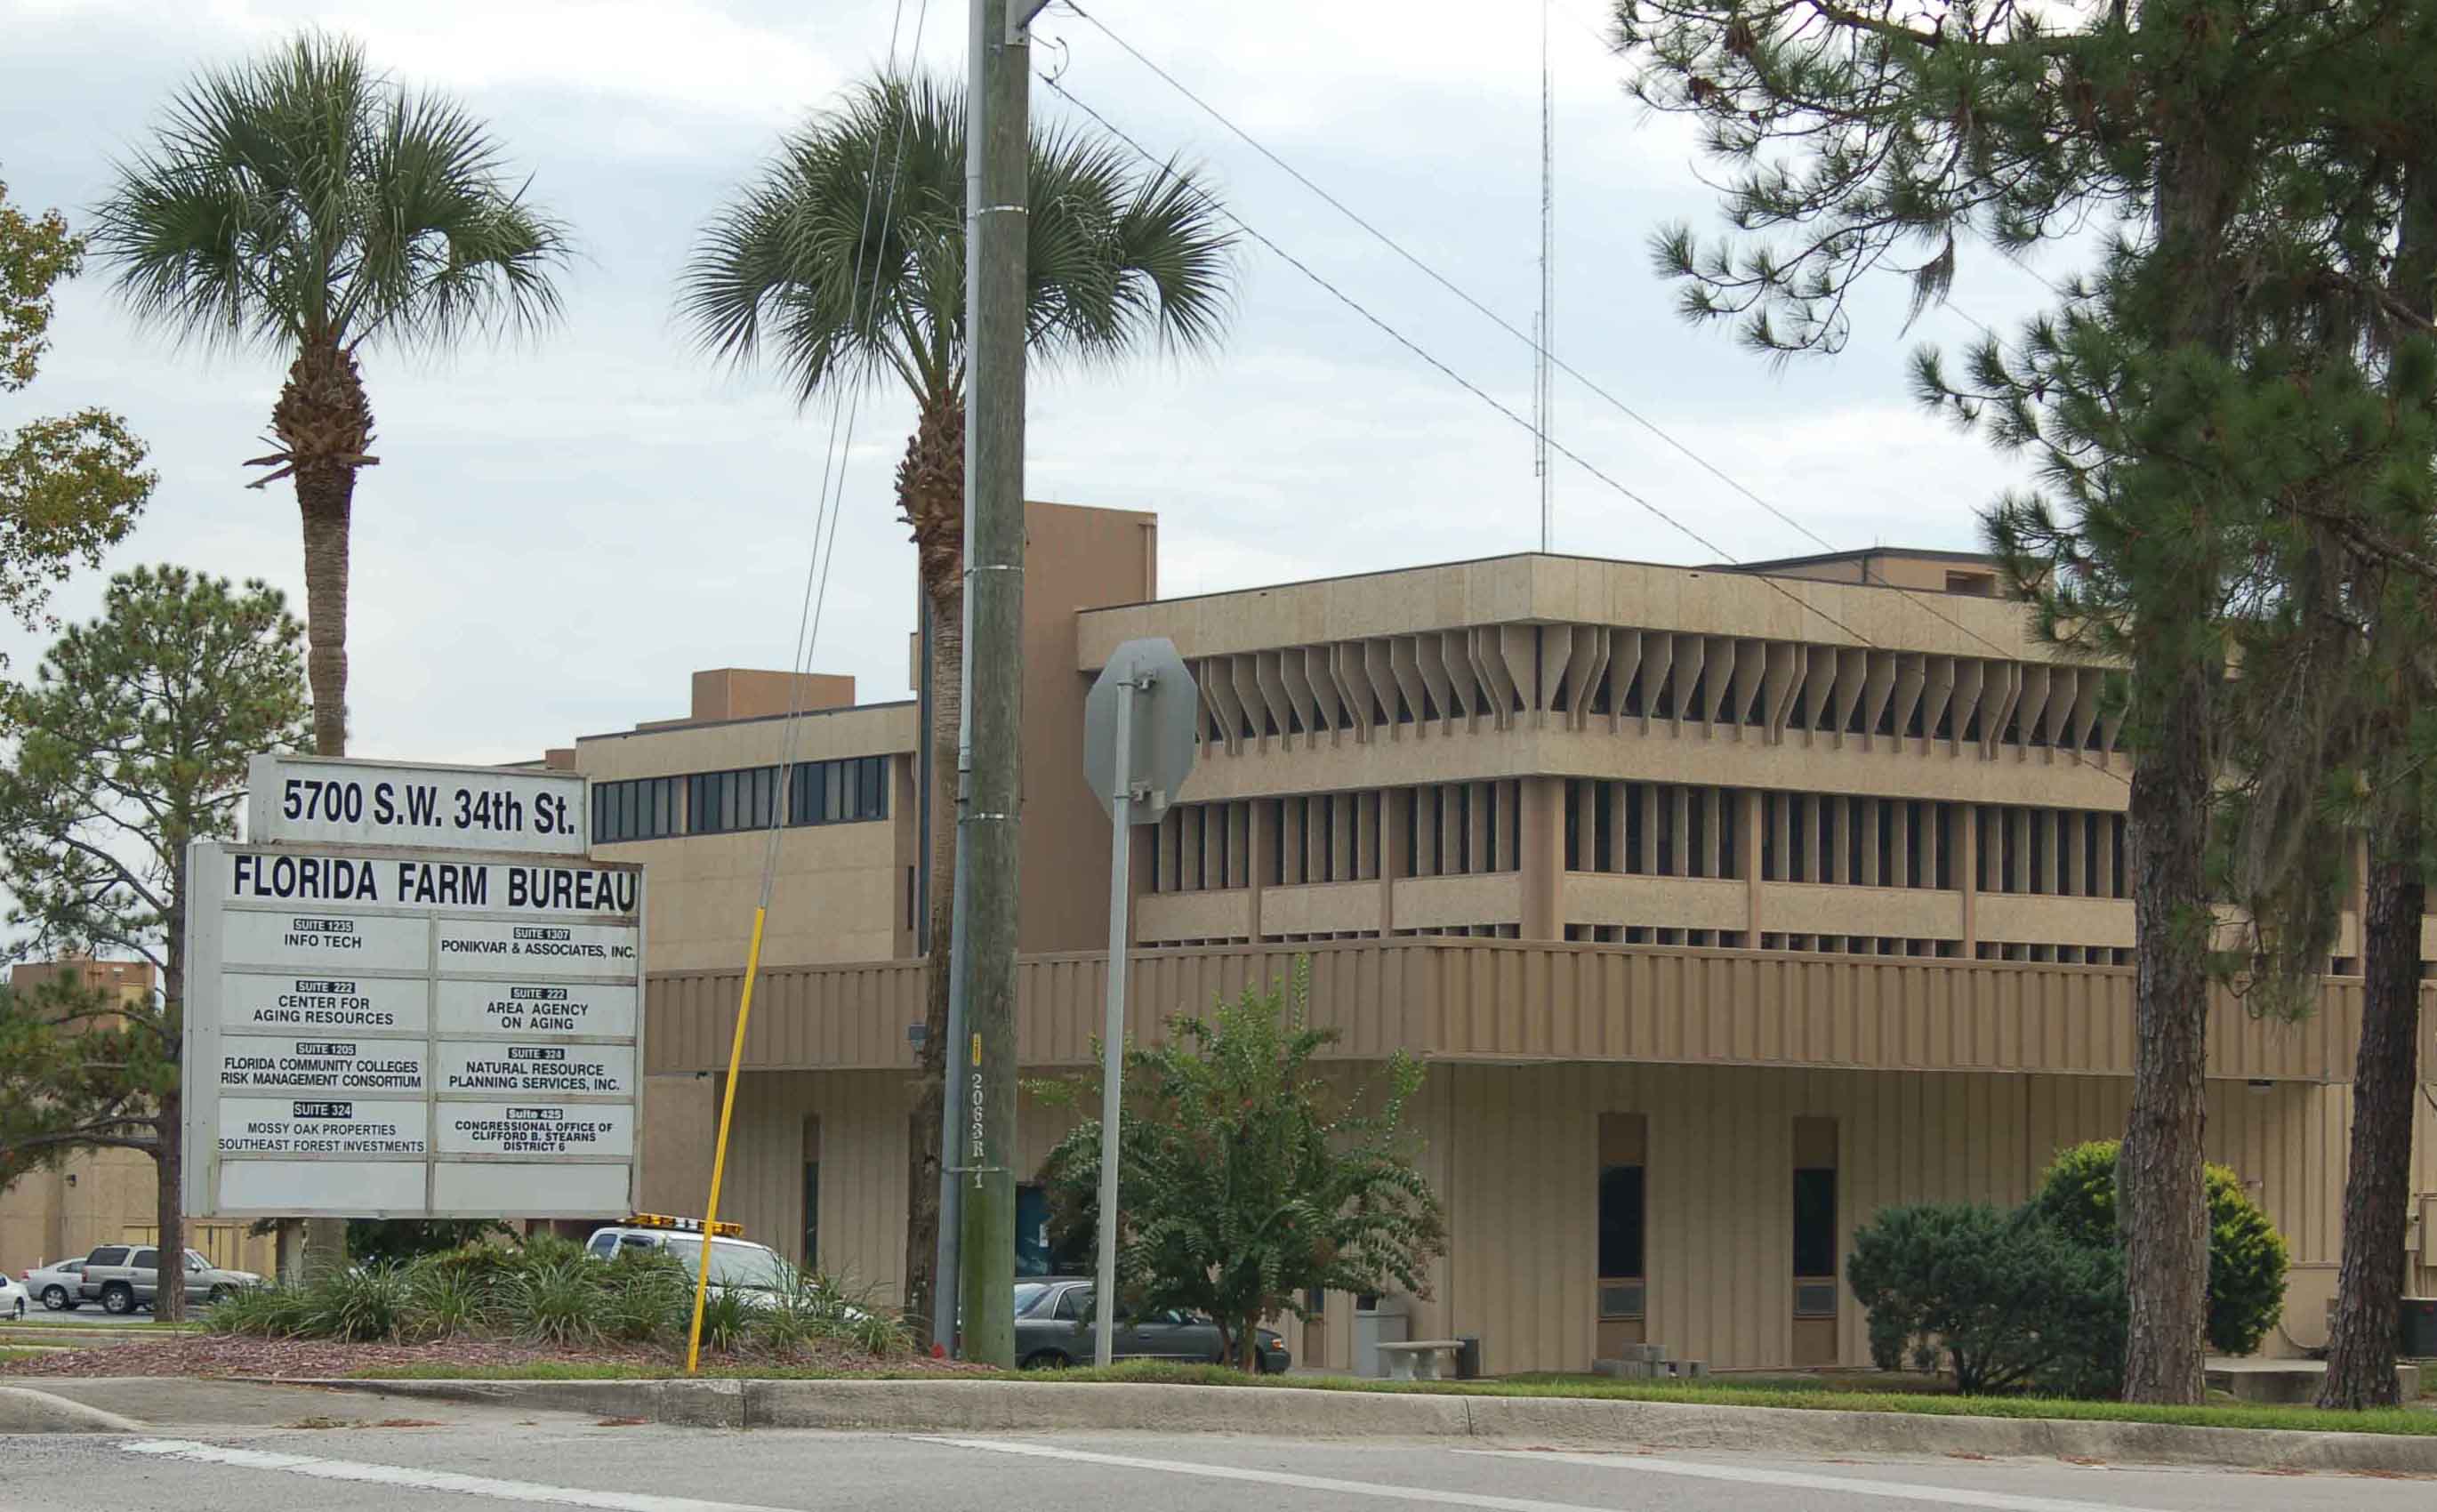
[92,32,567,756]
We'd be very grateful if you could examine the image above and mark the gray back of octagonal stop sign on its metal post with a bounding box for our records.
[1082,639,1202,1365]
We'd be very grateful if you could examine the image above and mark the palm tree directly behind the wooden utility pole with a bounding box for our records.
[680,76,1233,1346]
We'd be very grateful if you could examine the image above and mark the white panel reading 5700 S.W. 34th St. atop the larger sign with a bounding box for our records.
[246,756,592,856]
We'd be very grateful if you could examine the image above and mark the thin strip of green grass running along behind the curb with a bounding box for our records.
[343,1361,2437,1436]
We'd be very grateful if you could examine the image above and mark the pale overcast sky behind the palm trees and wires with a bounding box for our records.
[0,0,2076,760]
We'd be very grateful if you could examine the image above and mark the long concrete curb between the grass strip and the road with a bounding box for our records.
[287,1380,2437,1476]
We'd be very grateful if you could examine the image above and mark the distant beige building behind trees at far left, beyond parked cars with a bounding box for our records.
[0,959,273,1278]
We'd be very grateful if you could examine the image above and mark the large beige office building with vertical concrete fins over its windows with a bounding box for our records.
[566,505,2437,1373]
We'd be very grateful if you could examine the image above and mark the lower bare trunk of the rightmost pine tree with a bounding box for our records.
[2318,815,2427,1407]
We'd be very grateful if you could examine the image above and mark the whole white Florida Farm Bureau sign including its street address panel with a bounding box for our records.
[185,756,643,1217]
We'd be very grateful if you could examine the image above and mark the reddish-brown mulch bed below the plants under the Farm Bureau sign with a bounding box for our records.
[0,1334,989,1380]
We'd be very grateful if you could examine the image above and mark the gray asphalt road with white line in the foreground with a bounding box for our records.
[0,1397,2437,1512]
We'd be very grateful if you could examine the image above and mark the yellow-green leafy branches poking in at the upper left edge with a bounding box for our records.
[0,170,156,629]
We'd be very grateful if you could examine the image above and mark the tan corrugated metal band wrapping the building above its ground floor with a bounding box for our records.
[646,939,2359,1081]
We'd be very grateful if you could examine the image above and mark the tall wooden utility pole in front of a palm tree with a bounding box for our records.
[945,0,1043,1368]
